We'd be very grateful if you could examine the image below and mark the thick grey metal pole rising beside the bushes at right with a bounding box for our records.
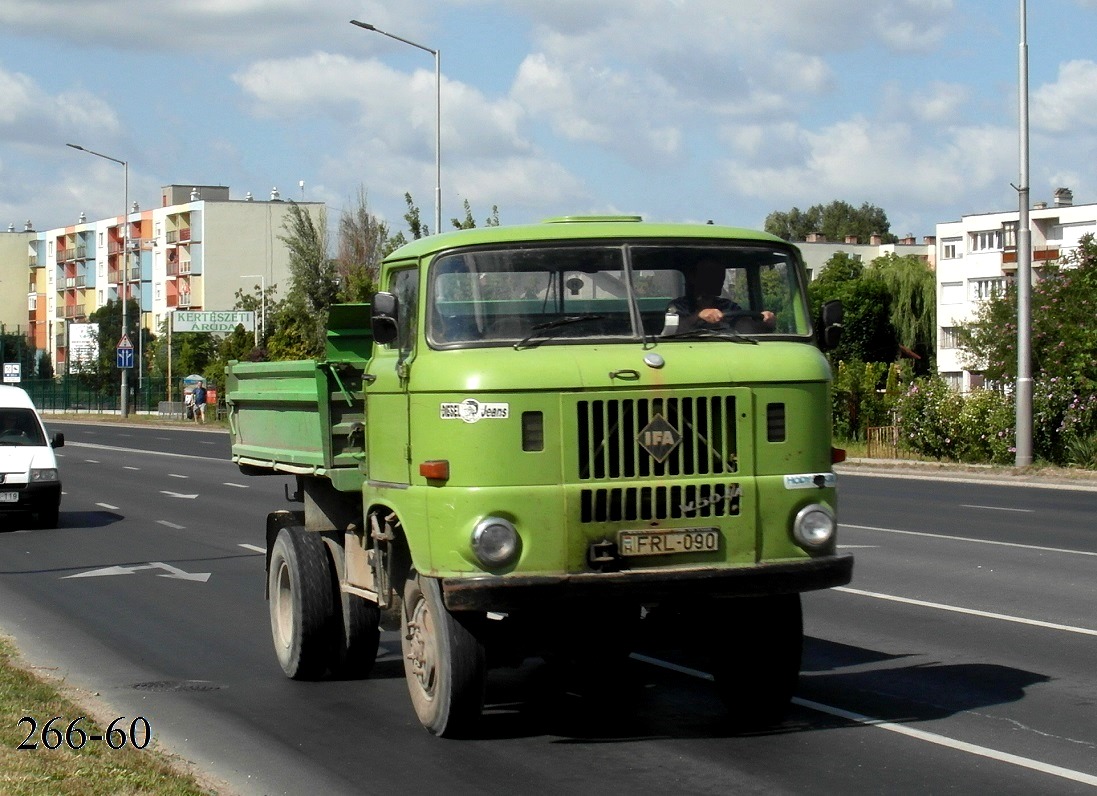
[1014,0,1032,467]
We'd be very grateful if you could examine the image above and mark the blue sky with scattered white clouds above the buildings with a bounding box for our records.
[0,0,1097,239]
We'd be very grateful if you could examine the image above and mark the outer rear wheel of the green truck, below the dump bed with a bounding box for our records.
[267,525,342,680]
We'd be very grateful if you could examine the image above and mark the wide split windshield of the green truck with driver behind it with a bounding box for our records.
[427,241,811,348]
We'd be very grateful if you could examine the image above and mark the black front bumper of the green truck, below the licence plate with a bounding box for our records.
[442,553,853,612]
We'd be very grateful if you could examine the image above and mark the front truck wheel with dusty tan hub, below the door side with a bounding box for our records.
[400,572,487,738]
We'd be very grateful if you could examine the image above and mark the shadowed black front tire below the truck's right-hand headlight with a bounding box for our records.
[712,594,804,729]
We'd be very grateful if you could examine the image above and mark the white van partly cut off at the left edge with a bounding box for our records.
[0,385,65,530]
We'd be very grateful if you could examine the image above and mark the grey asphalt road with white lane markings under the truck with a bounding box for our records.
[0,424,1097,794]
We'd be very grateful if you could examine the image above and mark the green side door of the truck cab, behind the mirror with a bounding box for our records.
[365,268,419,484]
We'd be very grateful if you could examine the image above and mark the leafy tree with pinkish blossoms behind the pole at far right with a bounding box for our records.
[958,235,1097,391]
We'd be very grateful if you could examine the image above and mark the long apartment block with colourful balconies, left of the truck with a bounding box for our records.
[23,185,324,372]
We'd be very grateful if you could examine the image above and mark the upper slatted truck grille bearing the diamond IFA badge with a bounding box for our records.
[576,396,737,480]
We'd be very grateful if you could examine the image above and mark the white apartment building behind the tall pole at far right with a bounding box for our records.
[937,187,1097,393]
